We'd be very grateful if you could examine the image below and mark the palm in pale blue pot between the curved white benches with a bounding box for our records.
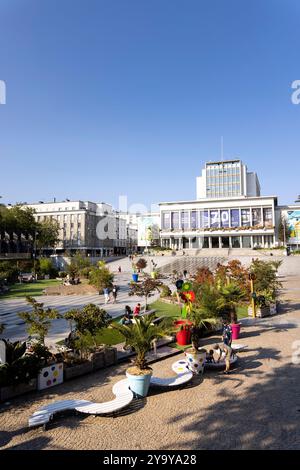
[112,314,172,397]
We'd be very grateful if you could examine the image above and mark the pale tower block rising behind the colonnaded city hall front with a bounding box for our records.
[196,160,260,200]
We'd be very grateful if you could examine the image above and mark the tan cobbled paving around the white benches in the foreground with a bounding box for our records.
[0,255,300,450]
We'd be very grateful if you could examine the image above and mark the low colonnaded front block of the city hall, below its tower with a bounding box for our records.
[159,196,277,249]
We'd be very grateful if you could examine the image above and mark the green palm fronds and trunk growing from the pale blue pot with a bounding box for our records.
[112,314,174,370]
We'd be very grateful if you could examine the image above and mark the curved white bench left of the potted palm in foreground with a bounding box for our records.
[28,379,133,427]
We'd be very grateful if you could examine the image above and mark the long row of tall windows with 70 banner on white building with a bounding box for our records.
[162,207,274,230]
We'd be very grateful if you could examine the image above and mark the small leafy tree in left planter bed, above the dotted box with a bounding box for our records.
[18,296,62,344]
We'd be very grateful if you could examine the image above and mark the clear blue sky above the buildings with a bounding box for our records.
[0,0,300,209]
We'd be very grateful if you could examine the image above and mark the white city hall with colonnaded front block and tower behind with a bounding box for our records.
[159,159,296,250]
